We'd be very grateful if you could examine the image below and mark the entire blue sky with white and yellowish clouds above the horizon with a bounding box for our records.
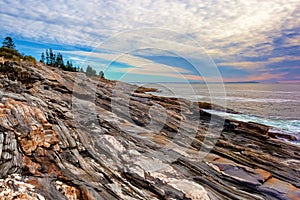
[0,0,300,83]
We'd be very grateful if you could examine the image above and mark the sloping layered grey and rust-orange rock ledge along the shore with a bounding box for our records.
[0,62,300,200]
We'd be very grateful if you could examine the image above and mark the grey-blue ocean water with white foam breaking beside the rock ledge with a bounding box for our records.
[146,83,300,140]
